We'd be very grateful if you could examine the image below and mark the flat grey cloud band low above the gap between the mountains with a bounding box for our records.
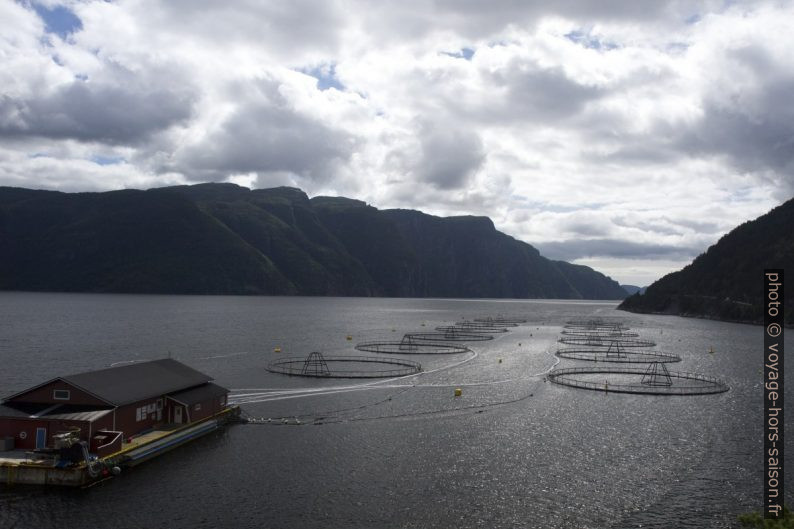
[534,239,701,261]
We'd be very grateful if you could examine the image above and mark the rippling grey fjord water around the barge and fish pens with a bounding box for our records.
[0,293,794,528]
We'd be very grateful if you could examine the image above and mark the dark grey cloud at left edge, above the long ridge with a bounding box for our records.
[0,81,192,144]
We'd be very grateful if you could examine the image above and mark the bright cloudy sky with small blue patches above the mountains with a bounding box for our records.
[0,0,794,285]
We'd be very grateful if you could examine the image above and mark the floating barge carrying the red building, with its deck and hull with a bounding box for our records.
[0,359,240,487]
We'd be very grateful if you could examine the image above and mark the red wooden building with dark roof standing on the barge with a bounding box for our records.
[0,358,229,451]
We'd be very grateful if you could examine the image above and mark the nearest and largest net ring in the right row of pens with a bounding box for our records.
[547,362,730,395]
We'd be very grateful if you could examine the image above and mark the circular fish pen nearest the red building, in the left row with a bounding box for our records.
[267,352,422,378]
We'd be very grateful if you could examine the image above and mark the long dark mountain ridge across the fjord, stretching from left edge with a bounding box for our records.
[0,184,625,299]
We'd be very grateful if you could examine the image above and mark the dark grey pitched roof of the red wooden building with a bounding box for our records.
[6,358,212,406]
